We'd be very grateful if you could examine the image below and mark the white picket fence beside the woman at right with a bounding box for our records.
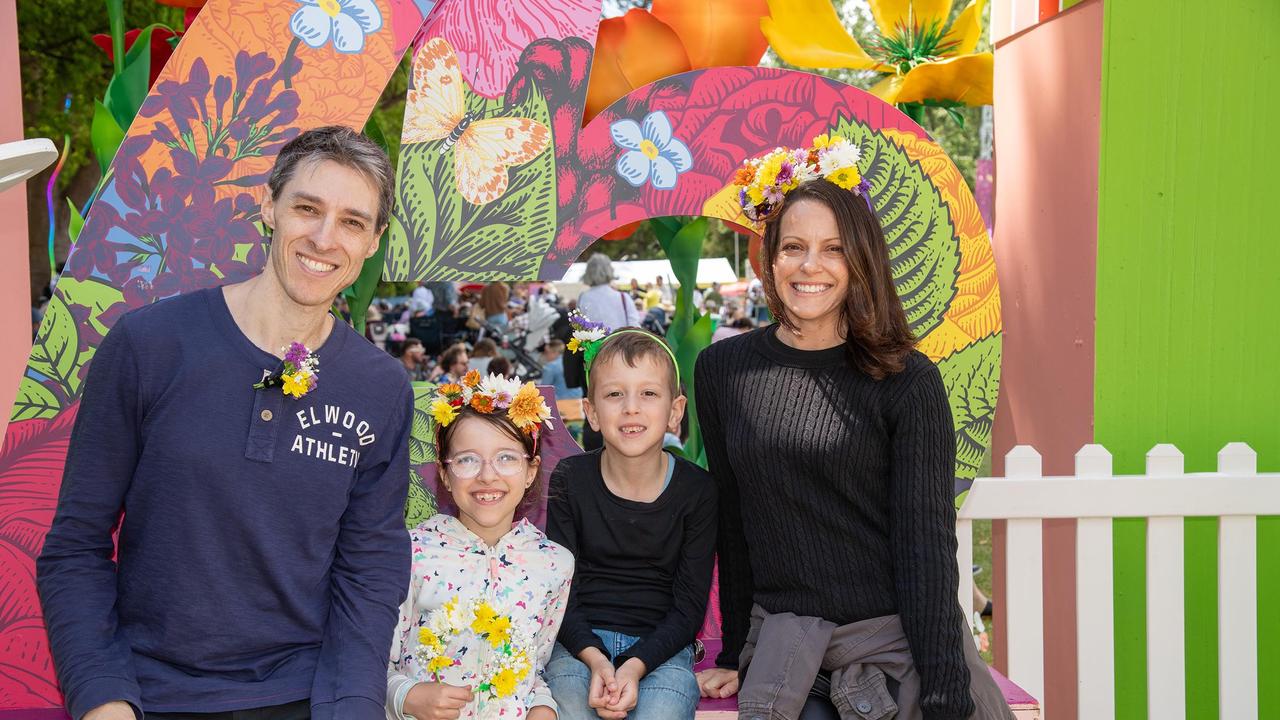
[956,442,1280,720]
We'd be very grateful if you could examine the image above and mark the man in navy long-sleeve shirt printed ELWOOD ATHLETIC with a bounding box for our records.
[37,127,412,720]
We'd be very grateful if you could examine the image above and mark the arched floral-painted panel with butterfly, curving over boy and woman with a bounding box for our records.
[387,63,1001,480]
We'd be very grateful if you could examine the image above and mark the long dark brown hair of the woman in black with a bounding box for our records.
[760,178,915,379]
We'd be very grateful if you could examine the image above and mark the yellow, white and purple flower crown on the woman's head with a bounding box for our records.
[733,133,870,223]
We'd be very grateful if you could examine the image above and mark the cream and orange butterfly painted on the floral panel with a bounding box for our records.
[403,37,550,205]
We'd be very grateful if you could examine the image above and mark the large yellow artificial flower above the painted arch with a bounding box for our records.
[760,0,995,120]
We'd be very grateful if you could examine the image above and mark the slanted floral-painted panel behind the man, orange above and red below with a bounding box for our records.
[0,0,433,708]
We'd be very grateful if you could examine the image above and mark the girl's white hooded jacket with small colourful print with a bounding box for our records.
[387,514,573,720]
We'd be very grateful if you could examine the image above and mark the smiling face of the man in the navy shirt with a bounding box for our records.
[262,160,381,307]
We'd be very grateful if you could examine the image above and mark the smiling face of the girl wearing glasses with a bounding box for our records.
[443,414,539,544]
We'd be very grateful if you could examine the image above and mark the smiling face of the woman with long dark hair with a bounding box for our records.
[772,200,849,333]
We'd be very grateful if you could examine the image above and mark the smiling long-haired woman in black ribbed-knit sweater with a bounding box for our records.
[695,170,1007,720]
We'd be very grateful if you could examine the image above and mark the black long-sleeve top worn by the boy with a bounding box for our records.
[547,450,717,671]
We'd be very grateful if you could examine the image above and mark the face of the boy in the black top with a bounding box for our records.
[582,354,686,457]
